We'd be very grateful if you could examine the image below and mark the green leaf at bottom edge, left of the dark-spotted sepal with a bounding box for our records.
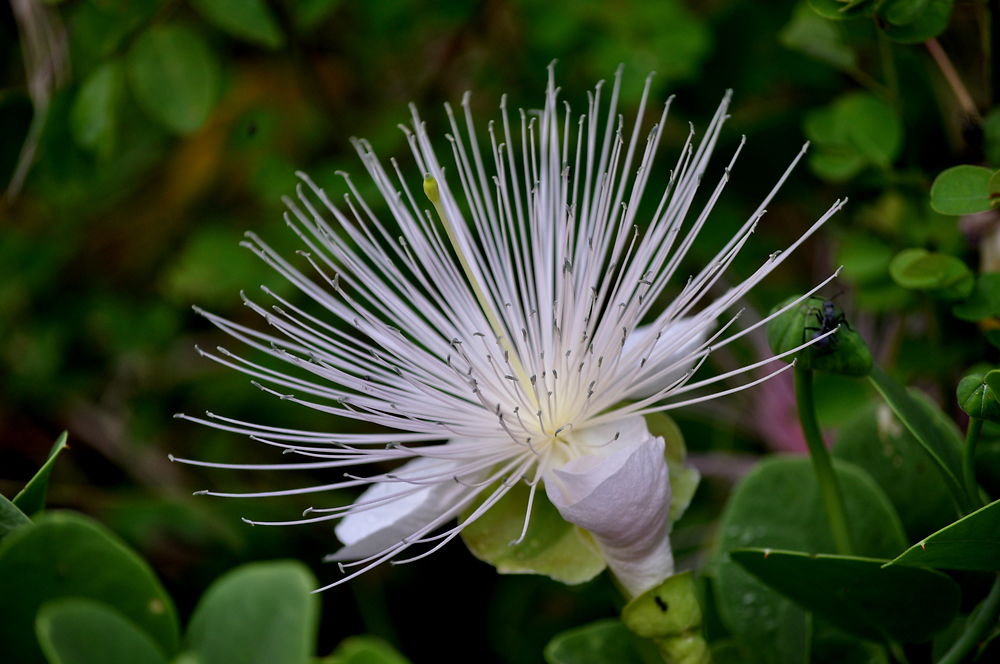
[545,619,663,664]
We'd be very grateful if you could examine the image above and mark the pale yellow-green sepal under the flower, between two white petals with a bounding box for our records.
[461,483,605,584]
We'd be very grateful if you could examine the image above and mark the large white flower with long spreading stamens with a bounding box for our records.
[174,69,841,595]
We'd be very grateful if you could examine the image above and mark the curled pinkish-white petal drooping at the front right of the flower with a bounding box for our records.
[545,417,674,596]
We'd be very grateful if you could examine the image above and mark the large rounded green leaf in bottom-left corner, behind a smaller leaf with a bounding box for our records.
[0,512,178,664]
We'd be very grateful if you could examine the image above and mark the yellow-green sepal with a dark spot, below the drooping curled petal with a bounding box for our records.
[622,572,711,664]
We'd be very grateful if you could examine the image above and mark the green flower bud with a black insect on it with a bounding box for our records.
[767,296,872,376]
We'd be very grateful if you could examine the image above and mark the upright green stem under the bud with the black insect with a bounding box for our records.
[795,367,854,555]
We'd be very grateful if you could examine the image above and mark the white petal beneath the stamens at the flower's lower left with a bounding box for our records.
[329,457,470,560]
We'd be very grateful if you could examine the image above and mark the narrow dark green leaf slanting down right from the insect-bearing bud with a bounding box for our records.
[869,367,966,506]
